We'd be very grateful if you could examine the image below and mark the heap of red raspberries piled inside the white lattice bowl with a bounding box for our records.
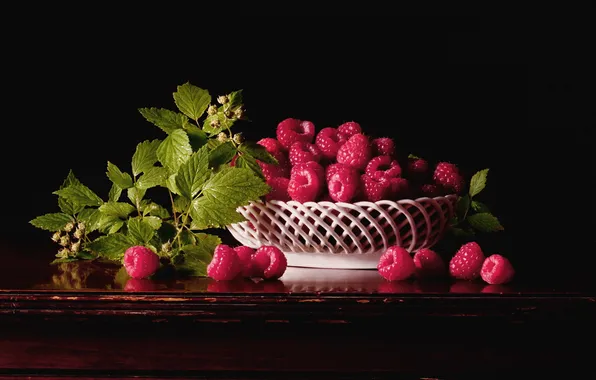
[257,118,465,203]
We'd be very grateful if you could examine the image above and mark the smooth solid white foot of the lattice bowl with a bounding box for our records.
[284,252,383,269]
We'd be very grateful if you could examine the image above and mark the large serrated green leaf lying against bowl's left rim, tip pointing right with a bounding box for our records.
[203,167,271,207]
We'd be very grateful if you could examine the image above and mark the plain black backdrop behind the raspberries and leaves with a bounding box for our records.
[0,11,595,288]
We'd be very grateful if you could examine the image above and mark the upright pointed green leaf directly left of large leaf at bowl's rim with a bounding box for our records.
[176,146,211,199]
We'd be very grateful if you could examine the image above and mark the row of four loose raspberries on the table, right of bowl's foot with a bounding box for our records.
[377,242,515,285]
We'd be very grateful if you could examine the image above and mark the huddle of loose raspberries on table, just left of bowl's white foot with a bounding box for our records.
[207,244,288,281]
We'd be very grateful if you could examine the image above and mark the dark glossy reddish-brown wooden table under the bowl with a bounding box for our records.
[0,239,596,379]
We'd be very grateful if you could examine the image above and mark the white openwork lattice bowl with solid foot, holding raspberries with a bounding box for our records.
[228,195,457,269]
